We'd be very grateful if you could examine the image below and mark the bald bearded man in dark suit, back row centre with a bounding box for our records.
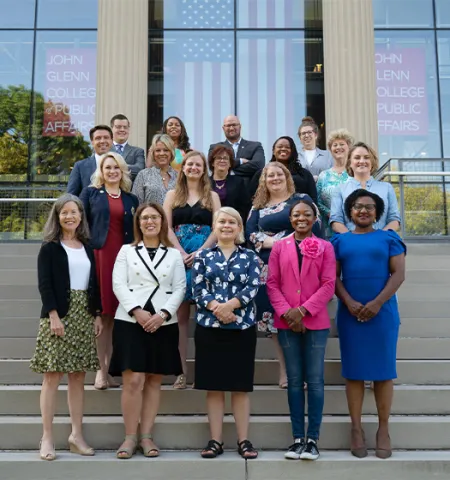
[209,115,266,180]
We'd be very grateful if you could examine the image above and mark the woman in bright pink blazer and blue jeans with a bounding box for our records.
[267,199,336,460]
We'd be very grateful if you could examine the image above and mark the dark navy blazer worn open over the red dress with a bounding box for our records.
[80,187,139,250]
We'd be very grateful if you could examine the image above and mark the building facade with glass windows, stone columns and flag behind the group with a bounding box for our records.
[0,0,450,188]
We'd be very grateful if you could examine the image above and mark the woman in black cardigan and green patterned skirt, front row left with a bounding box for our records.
[30,194,103,460]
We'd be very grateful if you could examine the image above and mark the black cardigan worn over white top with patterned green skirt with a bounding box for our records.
[38,242,102,318]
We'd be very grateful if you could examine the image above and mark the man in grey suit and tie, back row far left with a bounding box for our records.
[110,113,145,181]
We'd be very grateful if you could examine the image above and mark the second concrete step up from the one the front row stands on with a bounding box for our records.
[0,385,450,416]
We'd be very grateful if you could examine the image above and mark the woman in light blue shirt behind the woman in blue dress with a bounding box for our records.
[330,142,401,233]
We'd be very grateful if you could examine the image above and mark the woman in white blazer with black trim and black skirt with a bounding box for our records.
[110,203,186,458]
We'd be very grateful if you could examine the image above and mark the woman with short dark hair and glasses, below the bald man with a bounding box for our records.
[208,145,251,224]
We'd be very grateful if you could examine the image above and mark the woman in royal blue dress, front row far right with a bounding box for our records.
[332,189,406,458]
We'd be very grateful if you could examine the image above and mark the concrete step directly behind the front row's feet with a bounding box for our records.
[0,415,450,450]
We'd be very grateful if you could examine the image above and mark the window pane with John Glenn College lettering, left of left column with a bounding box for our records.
[31,31,97,181]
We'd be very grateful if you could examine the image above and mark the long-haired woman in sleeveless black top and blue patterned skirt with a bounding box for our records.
[163,151,220,389]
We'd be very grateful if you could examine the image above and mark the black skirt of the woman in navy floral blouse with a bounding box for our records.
[195,324,256,392]
